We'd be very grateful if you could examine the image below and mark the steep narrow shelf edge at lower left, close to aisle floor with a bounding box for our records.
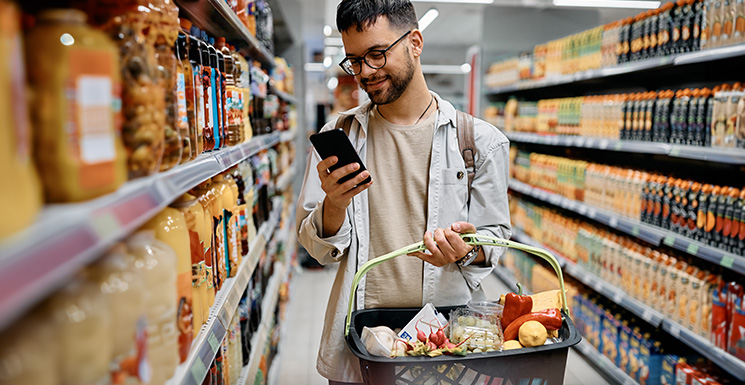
[238,263,287,385]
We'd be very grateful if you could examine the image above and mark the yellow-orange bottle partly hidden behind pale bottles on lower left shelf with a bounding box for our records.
[142,207,194,362]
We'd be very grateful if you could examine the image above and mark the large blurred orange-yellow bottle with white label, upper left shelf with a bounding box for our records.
[26,9,126,202]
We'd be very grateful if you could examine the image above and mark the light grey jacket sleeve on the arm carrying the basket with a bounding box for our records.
[461,124,512,290]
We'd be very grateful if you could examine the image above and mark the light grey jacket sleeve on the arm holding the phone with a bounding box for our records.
[295,129,352,265]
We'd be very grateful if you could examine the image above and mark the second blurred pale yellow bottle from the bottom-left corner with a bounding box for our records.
[44,273,114,385]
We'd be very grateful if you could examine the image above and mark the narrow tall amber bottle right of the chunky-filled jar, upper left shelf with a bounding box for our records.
[150,0,182,171]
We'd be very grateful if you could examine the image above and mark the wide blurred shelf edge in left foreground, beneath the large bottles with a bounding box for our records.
[0,133,279,329]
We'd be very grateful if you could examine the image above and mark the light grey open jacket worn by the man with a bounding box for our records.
[296,93,511,382]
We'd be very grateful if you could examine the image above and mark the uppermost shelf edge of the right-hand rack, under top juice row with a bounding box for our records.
[486,44,745,95]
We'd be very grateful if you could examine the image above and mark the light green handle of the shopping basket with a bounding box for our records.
[344,234,569,337]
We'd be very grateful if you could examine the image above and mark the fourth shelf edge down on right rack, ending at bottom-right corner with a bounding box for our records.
[513,230,745,381]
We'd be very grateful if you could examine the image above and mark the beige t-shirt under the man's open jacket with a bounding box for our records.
[365,108,437,308]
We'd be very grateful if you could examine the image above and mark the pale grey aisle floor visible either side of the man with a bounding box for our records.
[269,266,608,385]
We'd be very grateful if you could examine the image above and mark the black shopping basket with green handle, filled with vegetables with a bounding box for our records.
[344,234,582,385]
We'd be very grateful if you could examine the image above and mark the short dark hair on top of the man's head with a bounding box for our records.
[336,0,419,32]
